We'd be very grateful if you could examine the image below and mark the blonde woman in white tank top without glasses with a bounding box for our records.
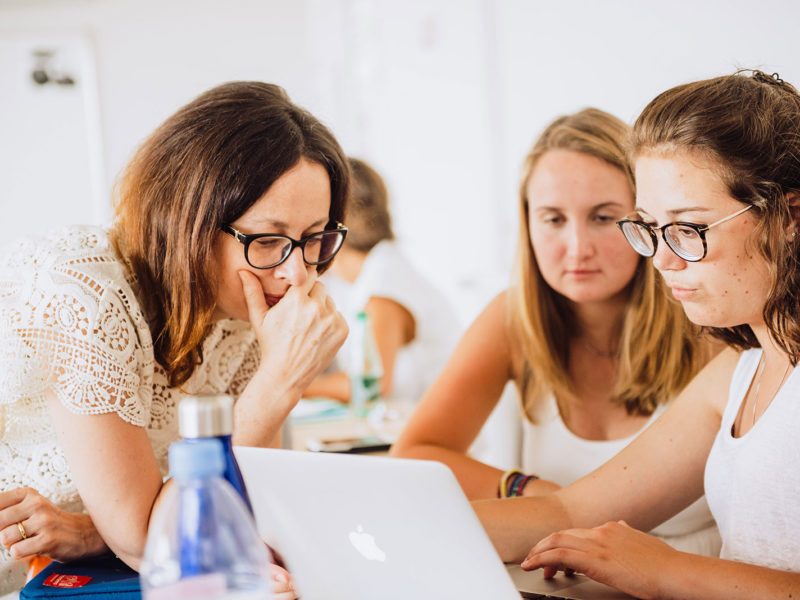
[393,108,719,554]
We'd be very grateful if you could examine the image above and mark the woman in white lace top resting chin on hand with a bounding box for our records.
[0,82,349,591]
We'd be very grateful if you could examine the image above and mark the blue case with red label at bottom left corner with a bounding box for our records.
[19,554,142,600]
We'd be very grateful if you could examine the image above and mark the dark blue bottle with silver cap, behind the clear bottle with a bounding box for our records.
[178,394,254,515]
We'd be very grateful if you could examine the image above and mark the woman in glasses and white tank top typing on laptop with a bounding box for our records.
[475,71,800,600]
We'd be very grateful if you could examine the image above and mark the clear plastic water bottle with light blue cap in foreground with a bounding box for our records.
[140,438,270,600]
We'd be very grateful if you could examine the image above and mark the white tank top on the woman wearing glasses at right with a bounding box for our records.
[705,350,800,572]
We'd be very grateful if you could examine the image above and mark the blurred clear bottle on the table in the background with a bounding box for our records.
[350,312,383,417]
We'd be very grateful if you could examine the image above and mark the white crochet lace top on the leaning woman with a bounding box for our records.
[0,227,258,594]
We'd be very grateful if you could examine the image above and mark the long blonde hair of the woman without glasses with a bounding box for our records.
[508,108,707,420]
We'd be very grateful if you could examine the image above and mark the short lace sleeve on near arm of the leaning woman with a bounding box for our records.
[0,250,153,426]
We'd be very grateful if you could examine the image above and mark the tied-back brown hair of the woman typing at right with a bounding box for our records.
[631,70,800,365]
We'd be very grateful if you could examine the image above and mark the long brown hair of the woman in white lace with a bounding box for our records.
[111,82,349,386]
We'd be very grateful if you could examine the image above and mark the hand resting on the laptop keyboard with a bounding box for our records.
[522,521,680,598]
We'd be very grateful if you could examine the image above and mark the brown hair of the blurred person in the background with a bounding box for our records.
[344,158,394,252]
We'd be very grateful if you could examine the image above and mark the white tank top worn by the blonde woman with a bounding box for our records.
[522,396,720,556]
